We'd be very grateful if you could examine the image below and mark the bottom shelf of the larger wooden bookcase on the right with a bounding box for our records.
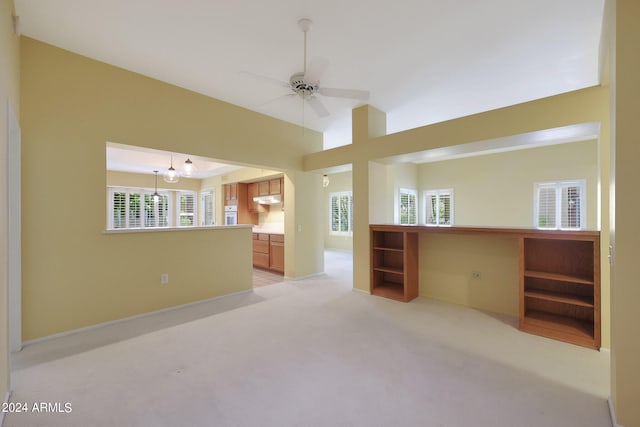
[520,311,598,348]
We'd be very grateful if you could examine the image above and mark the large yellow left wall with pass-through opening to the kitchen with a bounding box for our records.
[21,39,322,340]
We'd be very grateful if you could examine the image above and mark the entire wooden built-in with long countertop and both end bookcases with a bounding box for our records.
[370,225,600,349]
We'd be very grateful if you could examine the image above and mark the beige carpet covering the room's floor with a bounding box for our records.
[4,252,610,427]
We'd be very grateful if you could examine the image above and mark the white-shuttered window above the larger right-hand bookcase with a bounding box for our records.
[534,180,586,230]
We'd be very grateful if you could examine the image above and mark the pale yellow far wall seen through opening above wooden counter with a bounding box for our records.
[418,140,598,230]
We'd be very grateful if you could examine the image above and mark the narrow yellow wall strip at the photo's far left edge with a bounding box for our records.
[0,0,20,402]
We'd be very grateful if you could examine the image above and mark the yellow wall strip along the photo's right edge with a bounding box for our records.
[611,0,640,427]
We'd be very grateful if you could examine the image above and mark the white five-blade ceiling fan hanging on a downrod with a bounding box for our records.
[244,18,369,117]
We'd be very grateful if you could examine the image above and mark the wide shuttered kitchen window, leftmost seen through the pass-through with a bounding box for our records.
[109,188,169,229]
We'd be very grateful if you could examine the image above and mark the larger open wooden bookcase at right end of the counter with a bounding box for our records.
[520,236,600,348]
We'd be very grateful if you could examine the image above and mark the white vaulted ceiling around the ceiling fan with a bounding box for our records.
[15,0,604,148]
